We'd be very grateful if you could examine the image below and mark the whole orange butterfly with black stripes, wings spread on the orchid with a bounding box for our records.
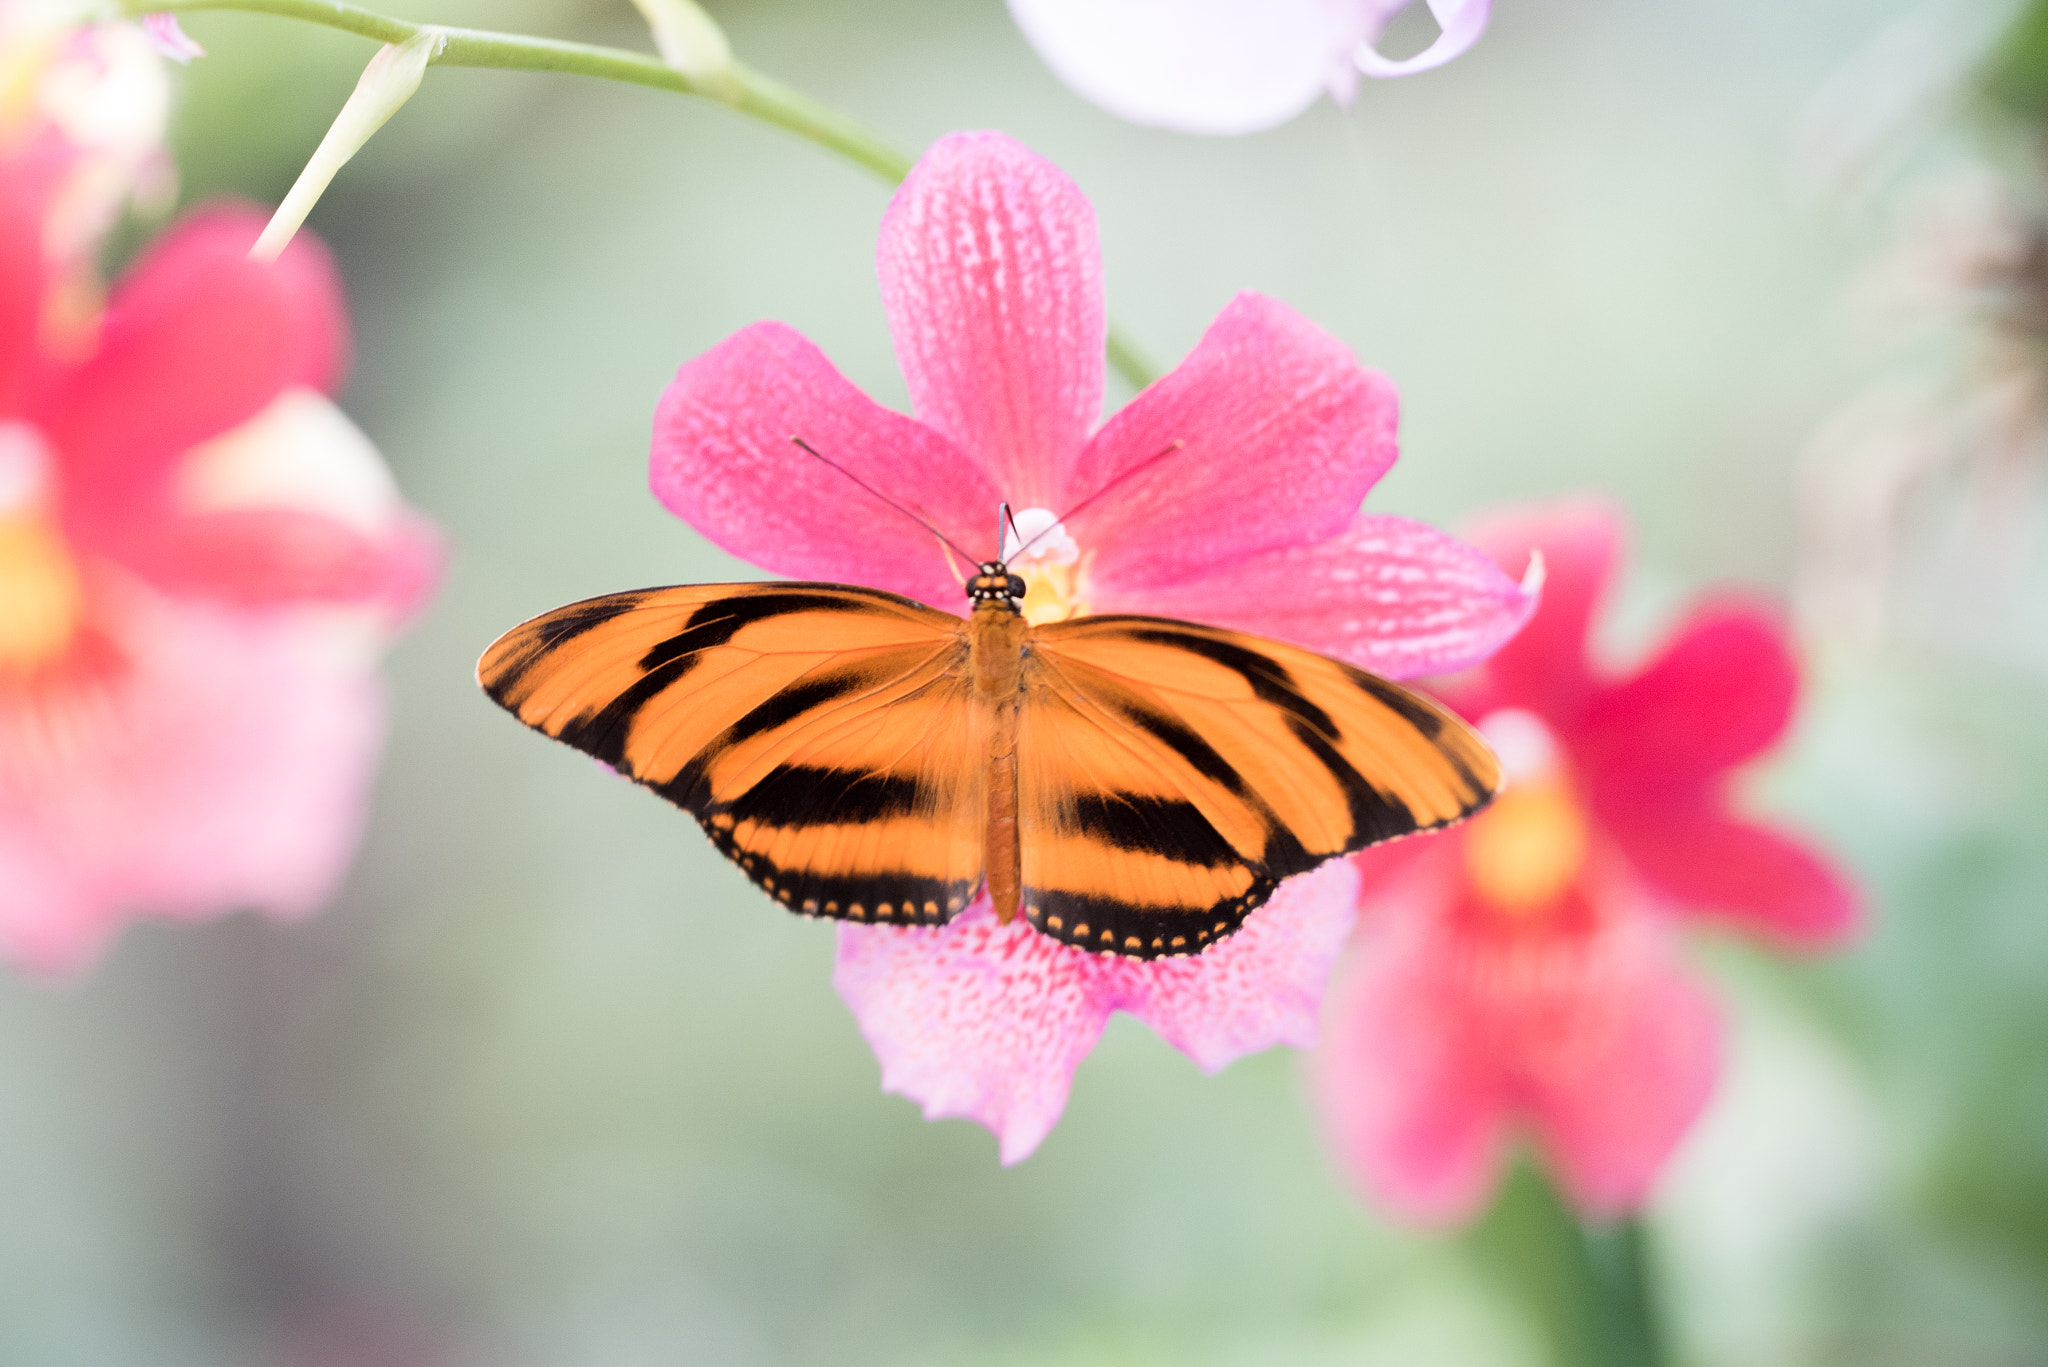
[477,562,1499,957]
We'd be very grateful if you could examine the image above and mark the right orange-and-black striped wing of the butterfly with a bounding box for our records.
[1018,617,1499,957]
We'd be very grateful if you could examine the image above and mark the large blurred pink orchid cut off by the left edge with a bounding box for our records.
[0,154,436,971]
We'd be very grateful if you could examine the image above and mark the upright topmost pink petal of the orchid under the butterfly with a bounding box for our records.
[877,133,1108,508]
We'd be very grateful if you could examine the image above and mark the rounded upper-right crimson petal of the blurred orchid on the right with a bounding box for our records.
[1573,598,1798,801]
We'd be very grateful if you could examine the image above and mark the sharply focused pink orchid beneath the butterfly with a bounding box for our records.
[651,133,1534,1162]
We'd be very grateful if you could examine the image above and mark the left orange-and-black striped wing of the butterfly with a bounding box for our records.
[477,584,987,922]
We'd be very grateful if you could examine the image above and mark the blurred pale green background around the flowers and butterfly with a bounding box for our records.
[0,0,2048,1367]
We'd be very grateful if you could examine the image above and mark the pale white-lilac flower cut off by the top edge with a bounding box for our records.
[1010,0,1493,135]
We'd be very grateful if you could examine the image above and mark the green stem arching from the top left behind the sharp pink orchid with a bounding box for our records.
[119,0,1153,389]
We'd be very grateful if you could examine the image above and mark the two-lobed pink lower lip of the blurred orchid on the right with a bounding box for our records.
[1315,836,1720,1221]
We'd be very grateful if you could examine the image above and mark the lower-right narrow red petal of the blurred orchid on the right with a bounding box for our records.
[1602,795,1862,949]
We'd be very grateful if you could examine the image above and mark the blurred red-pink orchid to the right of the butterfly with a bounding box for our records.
[1315,504,1858,1221]
